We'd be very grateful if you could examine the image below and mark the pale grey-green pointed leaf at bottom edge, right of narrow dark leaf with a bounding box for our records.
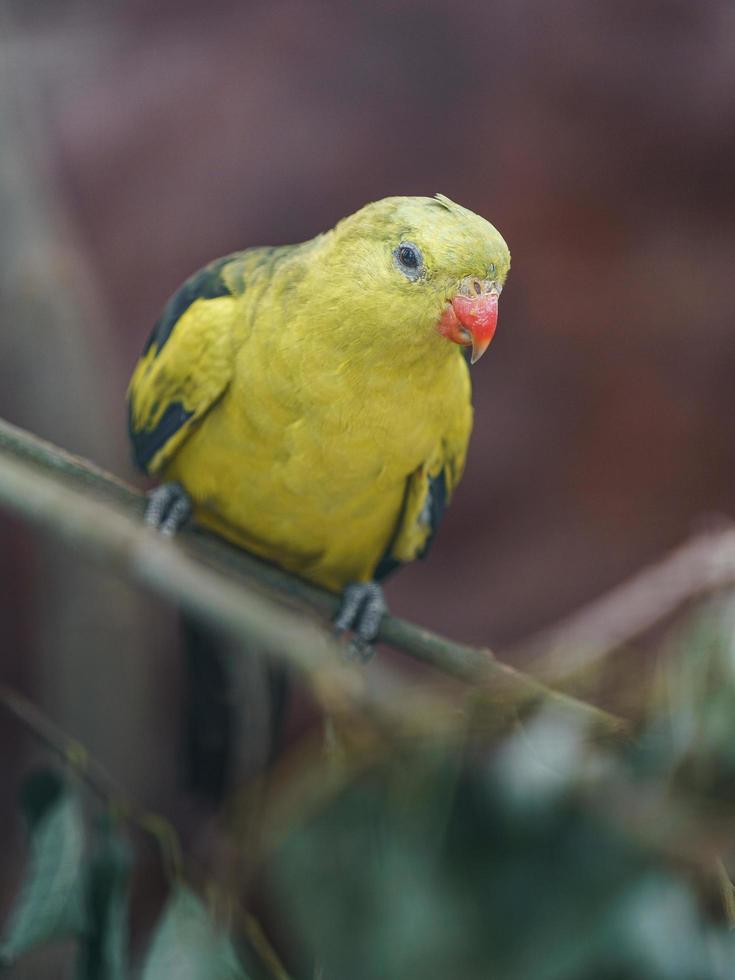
[141,885,247,980]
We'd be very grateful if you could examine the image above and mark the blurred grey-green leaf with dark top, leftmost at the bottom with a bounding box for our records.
[0,770,86,963]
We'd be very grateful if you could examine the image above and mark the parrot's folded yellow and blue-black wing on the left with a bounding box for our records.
[128,252,253,474]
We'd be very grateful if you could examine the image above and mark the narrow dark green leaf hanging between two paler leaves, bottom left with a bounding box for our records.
[77,817,133,980]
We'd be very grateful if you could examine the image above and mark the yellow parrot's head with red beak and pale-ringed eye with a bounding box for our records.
[325,194,510,364]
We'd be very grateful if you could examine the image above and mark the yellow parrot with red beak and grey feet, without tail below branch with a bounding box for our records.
[128,194,510,649]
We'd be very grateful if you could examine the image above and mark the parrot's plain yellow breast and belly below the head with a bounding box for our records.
[165,302,470,590]
